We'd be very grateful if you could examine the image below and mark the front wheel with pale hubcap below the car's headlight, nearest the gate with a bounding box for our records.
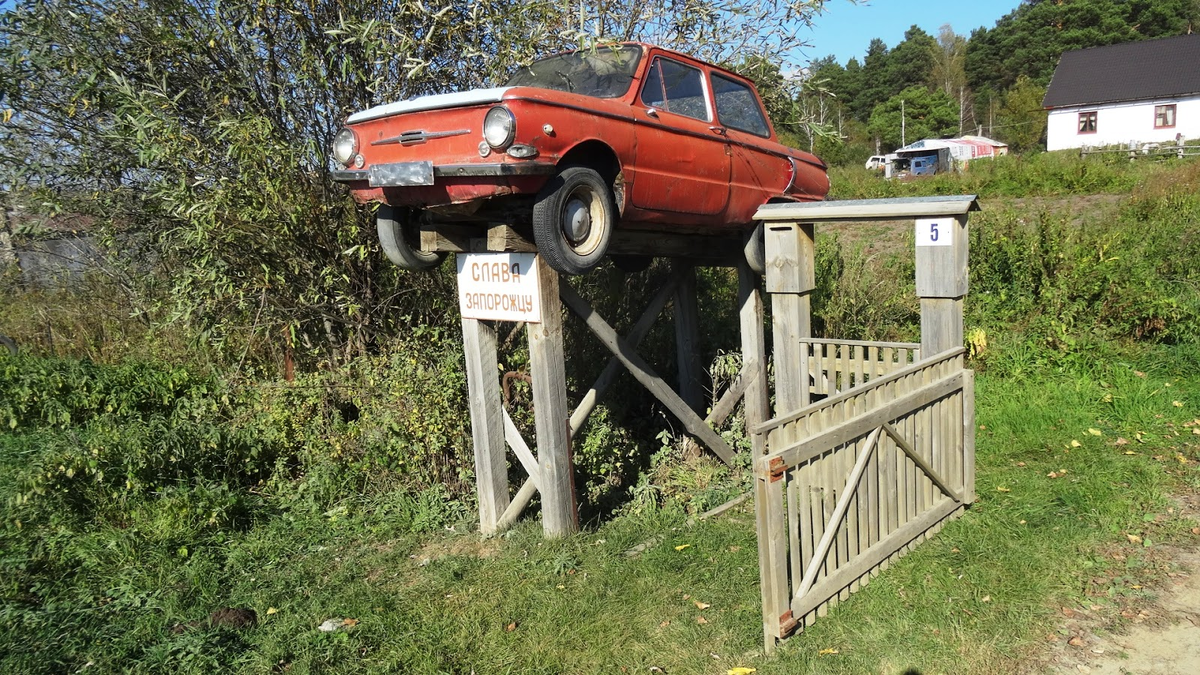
[533,167,617,274]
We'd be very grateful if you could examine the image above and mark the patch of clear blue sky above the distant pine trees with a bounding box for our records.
[800,0,1020,65]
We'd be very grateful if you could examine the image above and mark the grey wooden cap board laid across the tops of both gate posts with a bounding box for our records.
[754,195,979,222]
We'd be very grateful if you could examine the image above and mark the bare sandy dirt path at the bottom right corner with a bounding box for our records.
[1051,549,1200,675]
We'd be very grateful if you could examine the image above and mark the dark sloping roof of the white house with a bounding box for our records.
[1042,34,1200,108]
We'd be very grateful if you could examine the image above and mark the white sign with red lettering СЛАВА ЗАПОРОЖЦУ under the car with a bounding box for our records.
[457,253,541,323]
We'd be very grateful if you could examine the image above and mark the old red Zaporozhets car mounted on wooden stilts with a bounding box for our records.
[334,43,829,274]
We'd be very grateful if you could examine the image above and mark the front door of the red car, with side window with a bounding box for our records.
[631,55,730,215]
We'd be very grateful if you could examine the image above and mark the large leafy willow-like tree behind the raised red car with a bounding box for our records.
[0,0,840,362]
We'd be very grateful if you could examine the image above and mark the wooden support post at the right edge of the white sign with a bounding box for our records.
[526,256,580,537]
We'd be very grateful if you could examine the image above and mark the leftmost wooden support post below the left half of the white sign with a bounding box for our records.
[462,318,509,534]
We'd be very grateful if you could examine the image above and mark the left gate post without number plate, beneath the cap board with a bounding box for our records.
[766,222,816,414]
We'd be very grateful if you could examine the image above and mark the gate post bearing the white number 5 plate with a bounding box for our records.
[916,214,968,359]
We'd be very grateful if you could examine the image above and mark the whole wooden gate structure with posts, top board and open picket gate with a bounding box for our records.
[752,196,978,651]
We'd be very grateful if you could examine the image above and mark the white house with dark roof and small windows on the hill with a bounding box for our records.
[1042,35,1200,150]
